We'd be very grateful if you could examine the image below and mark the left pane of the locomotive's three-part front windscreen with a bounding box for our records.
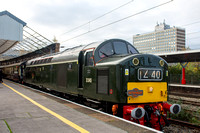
[99,43,114,58]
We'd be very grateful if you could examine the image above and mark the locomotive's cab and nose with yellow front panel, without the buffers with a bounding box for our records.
[79,39,168,104]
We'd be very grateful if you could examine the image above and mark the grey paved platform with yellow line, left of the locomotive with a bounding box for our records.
[0,80,159,133]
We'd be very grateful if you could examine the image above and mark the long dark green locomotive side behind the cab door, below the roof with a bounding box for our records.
[25,62,78,94]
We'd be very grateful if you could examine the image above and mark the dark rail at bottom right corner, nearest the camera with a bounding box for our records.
[168,119,200,131]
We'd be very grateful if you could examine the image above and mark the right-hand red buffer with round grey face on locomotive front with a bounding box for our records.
[163,103,181,114]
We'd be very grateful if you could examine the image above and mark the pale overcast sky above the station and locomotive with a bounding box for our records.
[0,0,200,49]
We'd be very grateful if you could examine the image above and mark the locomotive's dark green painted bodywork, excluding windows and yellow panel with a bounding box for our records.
[25,39,168,104]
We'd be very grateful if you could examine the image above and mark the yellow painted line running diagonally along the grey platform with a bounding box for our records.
[2,83,89,133]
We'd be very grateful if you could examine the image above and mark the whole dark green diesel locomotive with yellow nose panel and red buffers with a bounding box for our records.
[24,39,180,130]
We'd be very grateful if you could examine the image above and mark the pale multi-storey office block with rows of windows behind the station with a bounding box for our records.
[133,22,185,54]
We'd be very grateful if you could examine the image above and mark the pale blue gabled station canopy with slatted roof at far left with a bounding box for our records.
[0,11,53,61]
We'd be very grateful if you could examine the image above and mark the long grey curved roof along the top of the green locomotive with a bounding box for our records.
[26,39,138,66]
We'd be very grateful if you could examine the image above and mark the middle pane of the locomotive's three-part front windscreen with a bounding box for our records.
[114,42,128,54]
